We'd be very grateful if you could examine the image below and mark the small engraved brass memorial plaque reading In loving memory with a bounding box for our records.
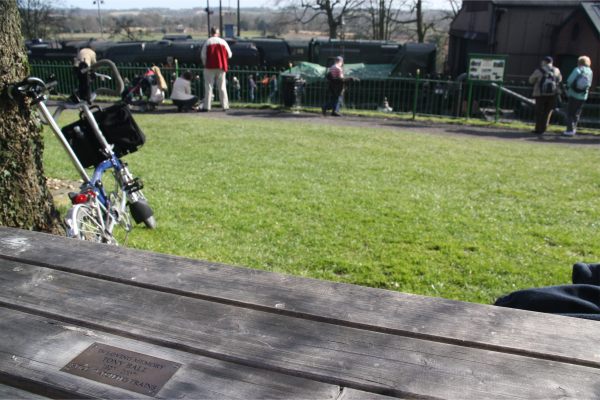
[61,343,181,396]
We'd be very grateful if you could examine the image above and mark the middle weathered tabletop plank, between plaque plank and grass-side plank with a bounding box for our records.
[0,260,600,399]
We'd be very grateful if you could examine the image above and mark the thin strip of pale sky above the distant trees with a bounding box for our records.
[60,0,448,10]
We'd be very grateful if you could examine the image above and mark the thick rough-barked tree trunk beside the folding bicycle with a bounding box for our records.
[0,0,62,233]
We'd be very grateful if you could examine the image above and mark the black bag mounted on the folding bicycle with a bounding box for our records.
[62,103,146,168]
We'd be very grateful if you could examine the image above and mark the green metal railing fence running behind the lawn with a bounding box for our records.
[31,62,600,128]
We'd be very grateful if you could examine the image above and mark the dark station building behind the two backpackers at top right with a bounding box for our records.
[446,0,600,85]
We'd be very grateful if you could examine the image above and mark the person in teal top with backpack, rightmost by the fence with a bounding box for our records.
[564,56,594,136]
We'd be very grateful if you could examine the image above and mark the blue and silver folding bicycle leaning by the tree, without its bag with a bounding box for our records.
[14,65,156,244]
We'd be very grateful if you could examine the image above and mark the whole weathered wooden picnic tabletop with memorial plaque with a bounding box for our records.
[0,228,600,400]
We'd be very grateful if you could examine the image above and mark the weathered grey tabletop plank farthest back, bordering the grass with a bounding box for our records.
[0,228,600,367]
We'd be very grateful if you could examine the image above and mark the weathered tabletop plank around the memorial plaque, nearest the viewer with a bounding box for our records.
[0,308,340,400]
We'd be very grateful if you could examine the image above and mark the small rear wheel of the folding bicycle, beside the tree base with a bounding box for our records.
[66,204,116,244]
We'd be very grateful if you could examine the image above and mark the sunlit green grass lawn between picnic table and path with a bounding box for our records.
[45,114,600,303]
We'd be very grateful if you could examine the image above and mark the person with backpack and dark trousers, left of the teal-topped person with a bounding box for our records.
[529,56,562,135]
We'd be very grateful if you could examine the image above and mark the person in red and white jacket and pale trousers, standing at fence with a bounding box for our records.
[200,27,231,111]
